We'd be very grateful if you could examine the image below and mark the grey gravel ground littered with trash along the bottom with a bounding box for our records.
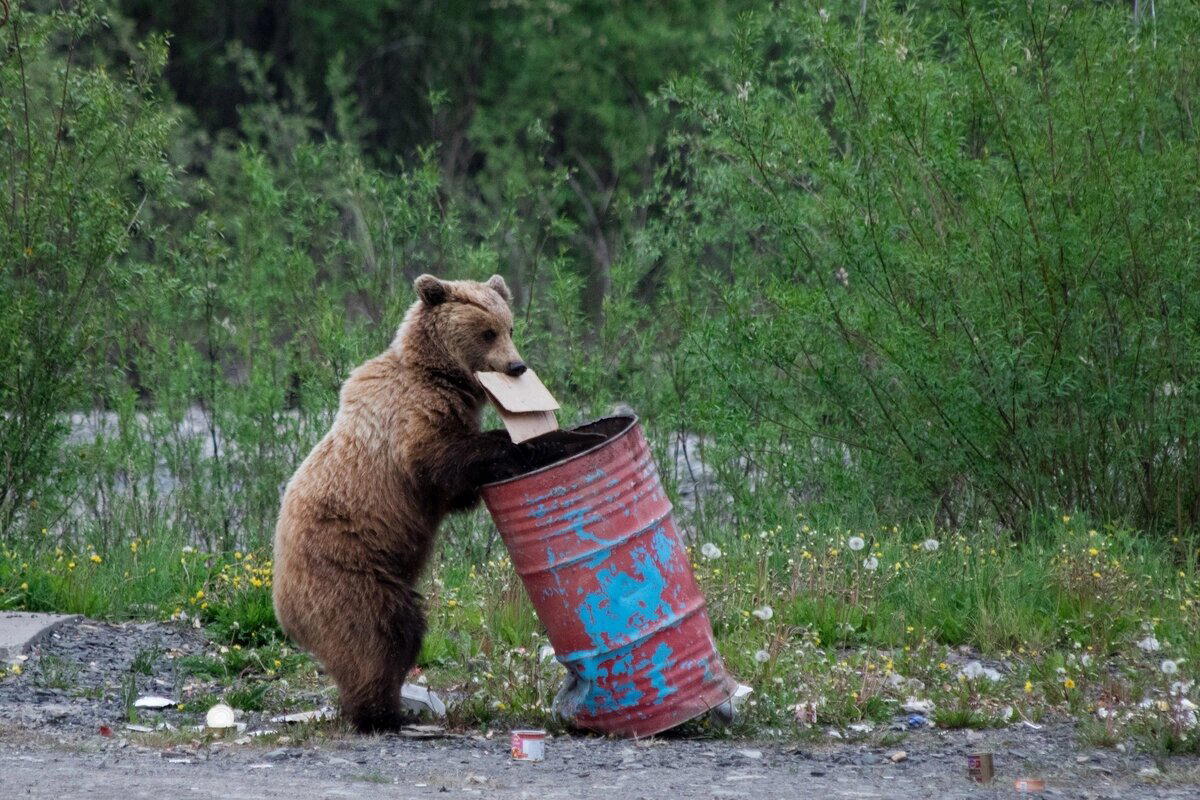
[0,621,1200,800]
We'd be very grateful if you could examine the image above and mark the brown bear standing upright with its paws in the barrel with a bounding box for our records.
[272,275,595,732]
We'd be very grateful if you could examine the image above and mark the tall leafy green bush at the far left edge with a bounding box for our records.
[0,2,173,533]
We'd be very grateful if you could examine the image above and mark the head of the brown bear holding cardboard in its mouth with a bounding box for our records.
[398,275,526,377]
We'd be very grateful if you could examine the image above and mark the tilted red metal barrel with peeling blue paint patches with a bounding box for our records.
[482,416,737,736]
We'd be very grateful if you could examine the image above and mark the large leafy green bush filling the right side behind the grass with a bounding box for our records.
[664,2,1200,529]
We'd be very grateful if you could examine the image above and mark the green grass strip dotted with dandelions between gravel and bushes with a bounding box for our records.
[0,506,1200,753]
